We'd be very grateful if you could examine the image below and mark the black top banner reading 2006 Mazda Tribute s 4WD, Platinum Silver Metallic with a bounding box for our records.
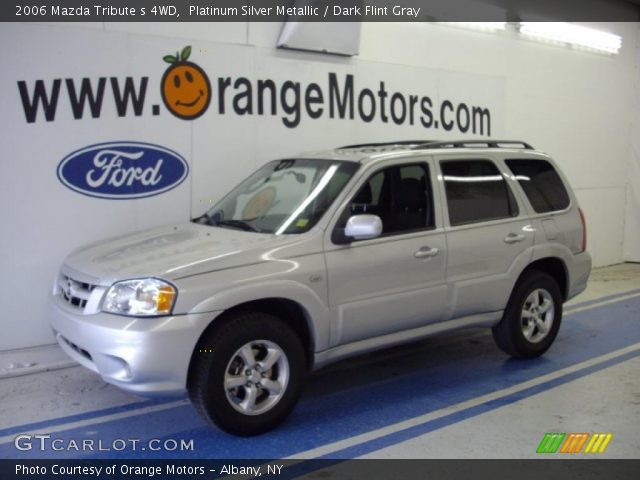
[0,0,640,22]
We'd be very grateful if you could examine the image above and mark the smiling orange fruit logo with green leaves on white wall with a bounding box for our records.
[160,46,211,120]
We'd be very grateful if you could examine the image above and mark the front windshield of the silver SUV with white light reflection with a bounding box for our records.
[193,159,359,235]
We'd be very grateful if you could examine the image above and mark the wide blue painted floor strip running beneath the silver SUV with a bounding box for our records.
[0,292,640,458]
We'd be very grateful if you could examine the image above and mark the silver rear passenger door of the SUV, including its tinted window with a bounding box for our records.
[437,157,534,318]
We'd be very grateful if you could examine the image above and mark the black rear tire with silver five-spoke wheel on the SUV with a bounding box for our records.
[493,271,562,358]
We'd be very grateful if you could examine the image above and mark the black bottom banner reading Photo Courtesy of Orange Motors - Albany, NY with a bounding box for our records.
[0,459,640,480]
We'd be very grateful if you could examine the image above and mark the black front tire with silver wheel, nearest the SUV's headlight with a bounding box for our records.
[188,312,306,437]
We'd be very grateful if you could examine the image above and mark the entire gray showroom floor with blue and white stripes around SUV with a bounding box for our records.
[0,264,640,459]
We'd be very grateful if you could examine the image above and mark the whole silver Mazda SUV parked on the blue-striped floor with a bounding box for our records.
[51,140,591,435]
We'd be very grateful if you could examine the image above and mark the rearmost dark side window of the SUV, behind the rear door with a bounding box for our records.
[506,160,569,213]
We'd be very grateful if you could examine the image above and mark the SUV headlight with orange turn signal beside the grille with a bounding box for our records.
[102,278,178,316]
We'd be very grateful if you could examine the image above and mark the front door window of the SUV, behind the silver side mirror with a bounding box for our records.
[336,164,435,240]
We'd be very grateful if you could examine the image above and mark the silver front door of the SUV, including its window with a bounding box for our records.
[325,160,447,346]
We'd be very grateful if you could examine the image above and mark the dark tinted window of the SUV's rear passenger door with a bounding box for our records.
[440,160,518,226]
